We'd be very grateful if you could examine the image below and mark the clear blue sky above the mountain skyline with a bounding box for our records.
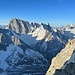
[0,0,75,26]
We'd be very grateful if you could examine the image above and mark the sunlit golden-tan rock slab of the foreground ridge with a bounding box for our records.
[46,39,75,75]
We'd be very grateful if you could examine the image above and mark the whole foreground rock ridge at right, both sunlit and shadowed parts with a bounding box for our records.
[46,39,75,75]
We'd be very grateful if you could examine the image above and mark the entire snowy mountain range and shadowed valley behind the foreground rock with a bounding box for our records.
[0,18,75,75]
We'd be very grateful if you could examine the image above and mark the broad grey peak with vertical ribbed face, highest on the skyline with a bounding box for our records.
[7,18,31,34]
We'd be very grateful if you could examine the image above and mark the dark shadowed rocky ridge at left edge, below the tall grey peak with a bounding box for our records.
[0,29,21,45]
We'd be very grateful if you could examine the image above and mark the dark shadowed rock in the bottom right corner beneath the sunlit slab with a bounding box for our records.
[54,50,75,75]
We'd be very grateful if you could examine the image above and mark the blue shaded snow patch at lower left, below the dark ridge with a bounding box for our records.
[0,44,23,70]
